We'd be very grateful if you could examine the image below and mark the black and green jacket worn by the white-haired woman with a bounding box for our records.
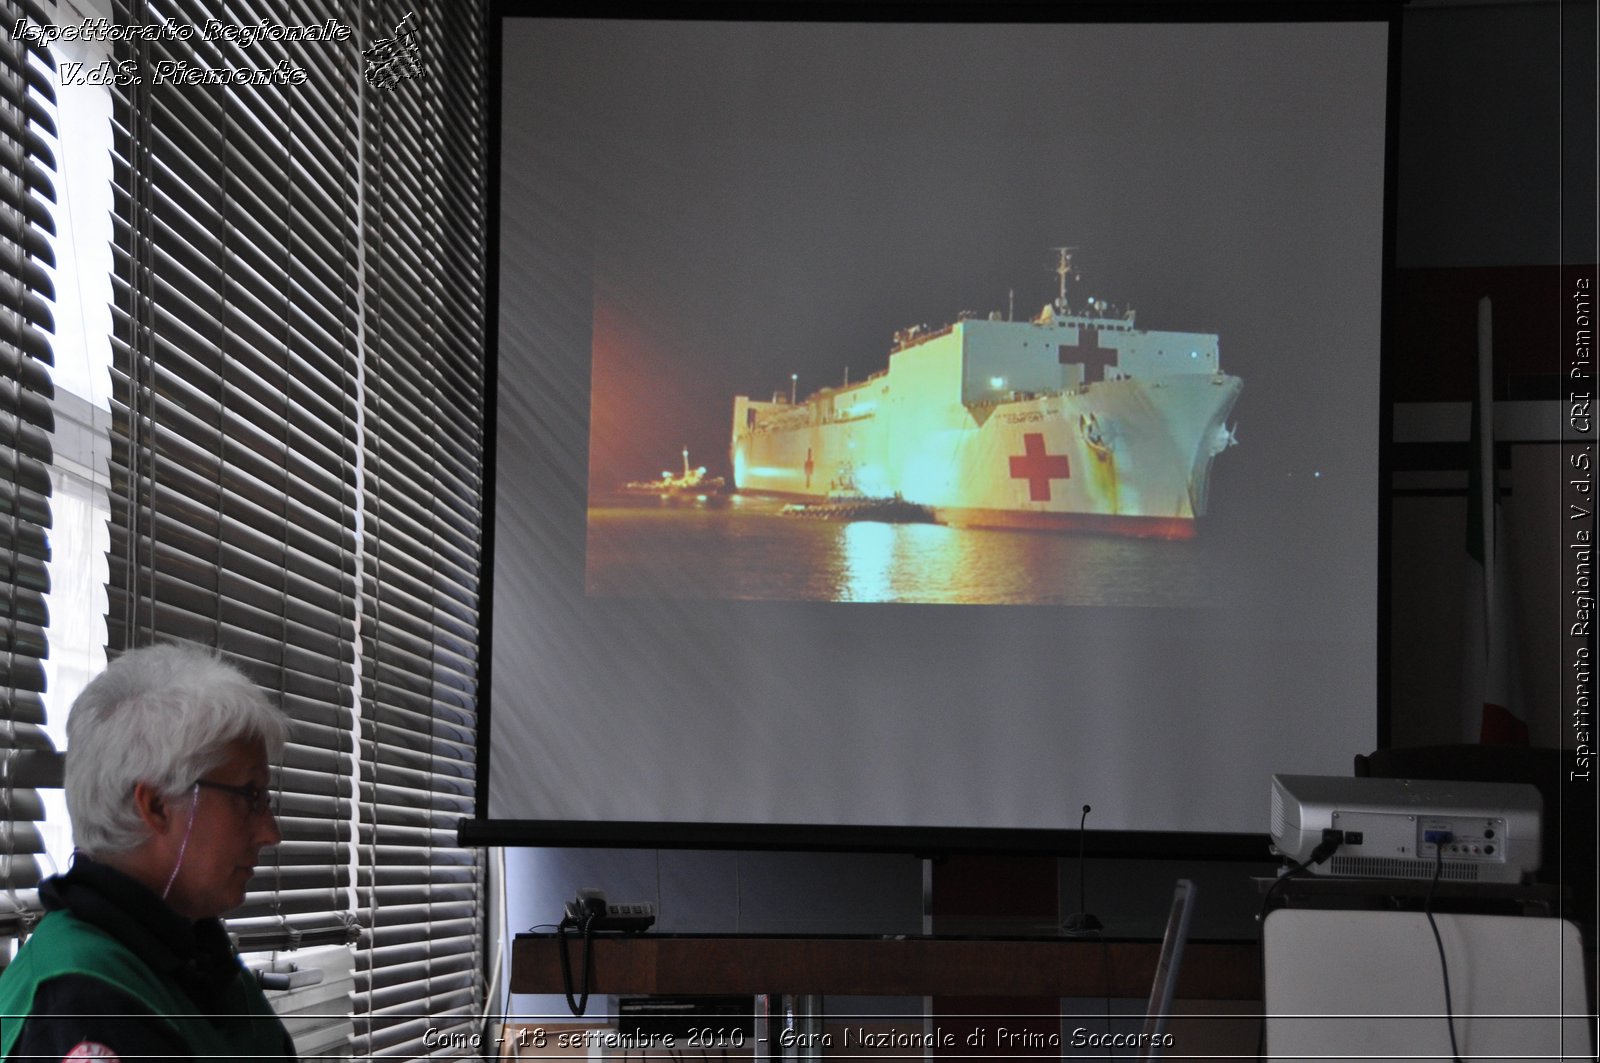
[0,855,294,1060]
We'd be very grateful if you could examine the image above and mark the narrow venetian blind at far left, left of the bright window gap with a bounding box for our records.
[0,0,61,935]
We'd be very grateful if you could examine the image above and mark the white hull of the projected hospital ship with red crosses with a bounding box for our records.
[731,312,1242,540]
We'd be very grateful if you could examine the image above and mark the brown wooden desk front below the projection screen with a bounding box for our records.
[510,933,1261,1001]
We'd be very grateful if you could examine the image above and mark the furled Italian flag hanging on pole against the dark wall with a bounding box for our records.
[1461,299,1528,746]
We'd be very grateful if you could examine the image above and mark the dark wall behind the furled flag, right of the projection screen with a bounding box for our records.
[1389,3,1595,746]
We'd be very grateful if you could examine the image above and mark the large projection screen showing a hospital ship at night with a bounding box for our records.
[469,8,1390,848]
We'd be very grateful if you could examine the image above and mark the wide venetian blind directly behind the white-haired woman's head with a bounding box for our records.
[109,0,360,948]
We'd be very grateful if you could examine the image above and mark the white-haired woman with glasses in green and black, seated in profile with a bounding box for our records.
[0,645,294,1060]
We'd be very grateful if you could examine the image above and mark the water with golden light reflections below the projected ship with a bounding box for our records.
[587,498,1218,605]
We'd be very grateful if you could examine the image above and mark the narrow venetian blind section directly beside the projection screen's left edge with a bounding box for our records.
[355,0,486,1058]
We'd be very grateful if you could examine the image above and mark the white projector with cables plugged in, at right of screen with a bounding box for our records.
[1272,775,1544,882]
